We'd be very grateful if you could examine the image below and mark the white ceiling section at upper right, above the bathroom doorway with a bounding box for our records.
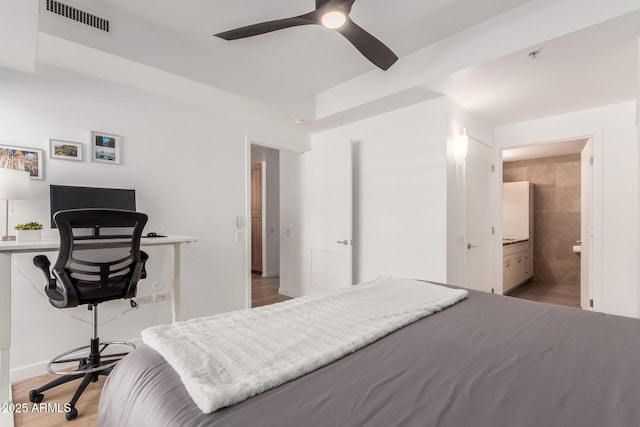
[425,13,640,125]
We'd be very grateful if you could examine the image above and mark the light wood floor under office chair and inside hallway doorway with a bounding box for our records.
[12,274,290,427]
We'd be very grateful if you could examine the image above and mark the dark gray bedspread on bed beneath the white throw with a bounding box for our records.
[99,291,640,427]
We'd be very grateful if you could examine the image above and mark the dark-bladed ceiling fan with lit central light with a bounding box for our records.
[215,0,398,70]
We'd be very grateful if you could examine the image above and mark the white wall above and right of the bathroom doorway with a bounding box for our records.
[495,102,640,317]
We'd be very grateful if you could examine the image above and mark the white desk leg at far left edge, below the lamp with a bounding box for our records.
[0,252,13,427]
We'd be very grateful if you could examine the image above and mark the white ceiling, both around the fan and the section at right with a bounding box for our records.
[52,0,640,125]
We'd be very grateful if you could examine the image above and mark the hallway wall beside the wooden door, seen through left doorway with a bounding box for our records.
[251,145,280,277]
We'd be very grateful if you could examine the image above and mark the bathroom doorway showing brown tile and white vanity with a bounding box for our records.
[501,138,593,308]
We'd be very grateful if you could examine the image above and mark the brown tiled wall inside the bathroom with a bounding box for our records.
[503,154,580,286]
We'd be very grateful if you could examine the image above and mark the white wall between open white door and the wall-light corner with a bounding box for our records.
[308,98,448,290]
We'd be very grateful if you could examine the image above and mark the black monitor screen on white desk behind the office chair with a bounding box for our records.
[49,185,136,228]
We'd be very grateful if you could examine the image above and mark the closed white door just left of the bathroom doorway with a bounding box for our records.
[464,137,496,292]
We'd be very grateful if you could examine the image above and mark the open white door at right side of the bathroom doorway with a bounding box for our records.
[576,138,594,310]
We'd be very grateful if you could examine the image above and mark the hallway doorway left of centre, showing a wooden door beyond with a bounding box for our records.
[246,136,302,308]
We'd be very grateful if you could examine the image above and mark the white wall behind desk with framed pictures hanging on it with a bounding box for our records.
[0,65,305,380]
